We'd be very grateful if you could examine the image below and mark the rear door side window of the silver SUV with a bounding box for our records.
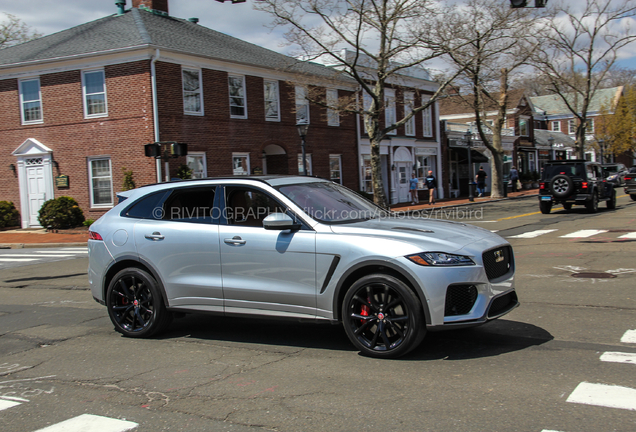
[161,186,218,224]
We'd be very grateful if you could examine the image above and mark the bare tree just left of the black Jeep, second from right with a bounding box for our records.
[437,0,537,197]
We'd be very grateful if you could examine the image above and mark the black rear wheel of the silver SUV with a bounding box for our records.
[106,267,171,338]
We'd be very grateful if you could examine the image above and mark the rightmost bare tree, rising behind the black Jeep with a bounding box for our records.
[535,0,636,158]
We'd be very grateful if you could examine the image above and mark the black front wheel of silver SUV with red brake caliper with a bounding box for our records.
[342,274,426,358]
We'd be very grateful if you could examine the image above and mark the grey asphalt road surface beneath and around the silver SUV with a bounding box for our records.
[0,196,636,432]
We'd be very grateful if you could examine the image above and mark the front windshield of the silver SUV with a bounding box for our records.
[278,182,387,224]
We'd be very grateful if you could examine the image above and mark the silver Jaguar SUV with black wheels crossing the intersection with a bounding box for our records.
[88,176,519,358]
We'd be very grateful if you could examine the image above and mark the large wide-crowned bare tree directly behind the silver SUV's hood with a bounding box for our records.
[255,0,468,207]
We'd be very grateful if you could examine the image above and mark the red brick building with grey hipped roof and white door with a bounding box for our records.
[0,0,360,228]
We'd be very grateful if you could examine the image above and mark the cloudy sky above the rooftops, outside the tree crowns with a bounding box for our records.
[0,0,636,69]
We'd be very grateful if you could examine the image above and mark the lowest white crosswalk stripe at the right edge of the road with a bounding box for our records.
[567,382,636,411]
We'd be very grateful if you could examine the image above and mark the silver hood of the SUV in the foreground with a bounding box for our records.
[331,217,506,253]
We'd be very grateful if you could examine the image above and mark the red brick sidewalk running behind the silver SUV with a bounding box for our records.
[0,189,538,249]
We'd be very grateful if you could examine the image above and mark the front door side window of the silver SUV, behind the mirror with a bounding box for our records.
[225,187,285,227]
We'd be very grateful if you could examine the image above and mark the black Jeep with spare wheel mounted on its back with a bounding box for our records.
[539,159,616,214]
